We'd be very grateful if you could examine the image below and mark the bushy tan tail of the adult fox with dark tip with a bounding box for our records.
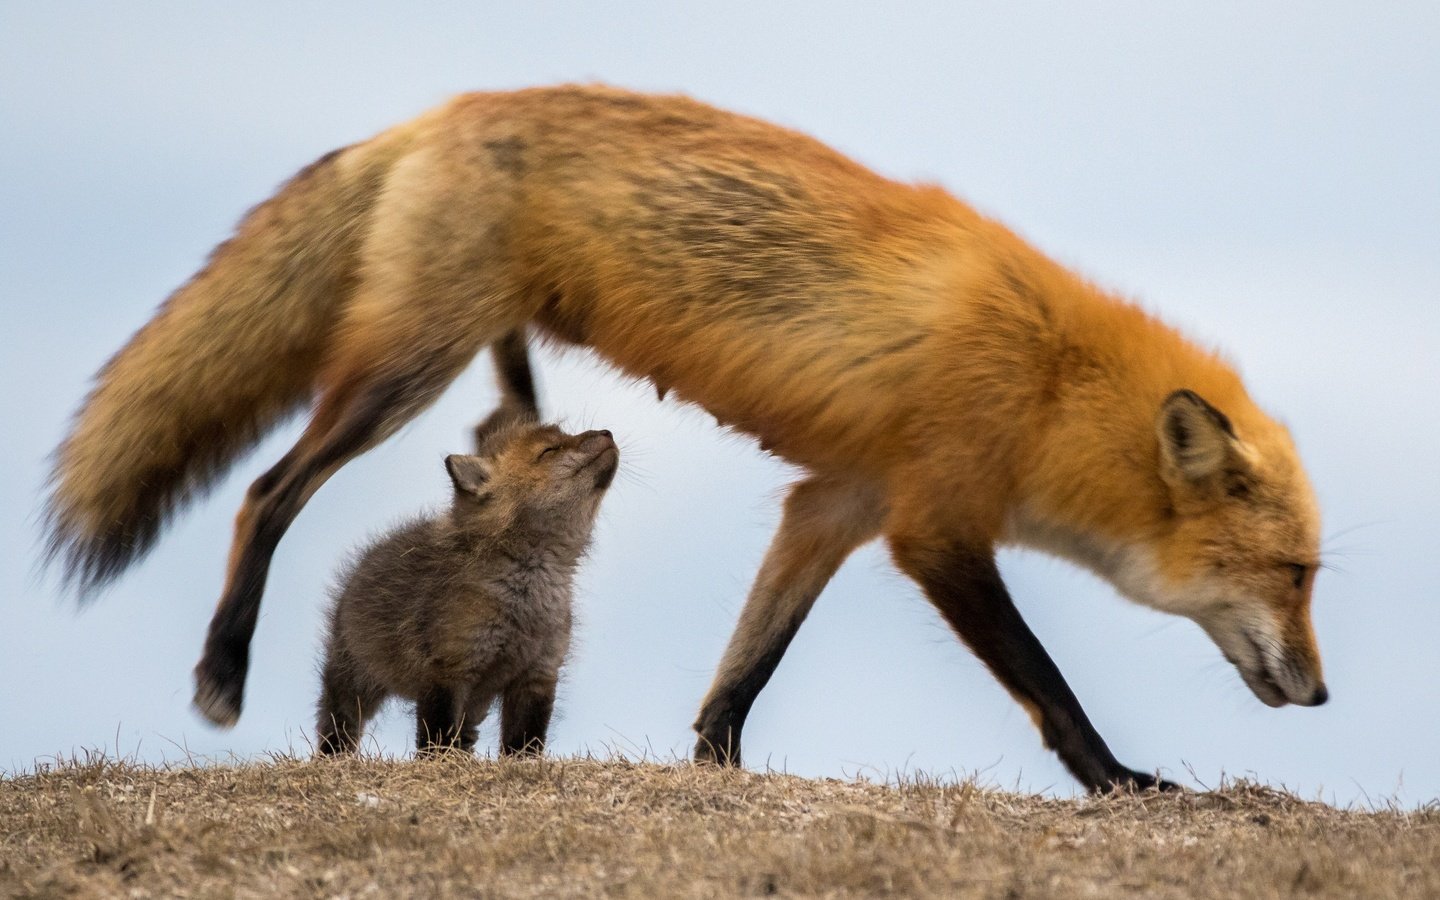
[46,144,390,595]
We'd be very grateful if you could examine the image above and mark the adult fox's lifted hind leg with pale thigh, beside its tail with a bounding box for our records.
[185,184,534,726]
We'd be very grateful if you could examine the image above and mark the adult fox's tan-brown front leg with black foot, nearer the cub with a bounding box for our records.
[694,477,884,765]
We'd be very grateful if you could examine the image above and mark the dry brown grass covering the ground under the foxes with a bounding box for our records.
[0,759,1440,897]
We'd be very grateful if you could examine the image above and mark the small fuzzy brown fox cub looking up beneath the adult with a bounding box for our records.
[315,416,619,755]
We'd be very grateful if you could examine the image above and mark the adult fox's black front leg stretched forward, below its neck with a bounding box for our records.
[890,537,1176,792]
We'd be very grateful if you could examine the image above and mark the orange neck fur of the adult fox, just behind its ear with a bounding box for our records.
[1002,276,1249,567]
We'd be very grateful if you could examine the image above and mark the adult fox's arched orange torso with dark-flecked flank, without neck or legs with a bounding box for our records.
[388,88,1028,469]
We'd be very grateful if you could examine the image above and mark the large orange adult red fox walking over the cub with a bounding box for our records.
[49,86,1326,791]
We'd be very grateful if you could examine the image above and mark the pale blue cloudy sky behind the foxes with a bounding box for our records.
[0,1,1440,804]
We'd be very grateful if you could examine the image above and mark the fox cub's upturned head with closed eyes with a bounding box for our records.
[445,415,619,524]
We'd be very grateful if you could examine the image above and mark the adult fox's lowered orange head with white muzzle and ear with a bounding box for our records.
[1125,390,1328,706]
